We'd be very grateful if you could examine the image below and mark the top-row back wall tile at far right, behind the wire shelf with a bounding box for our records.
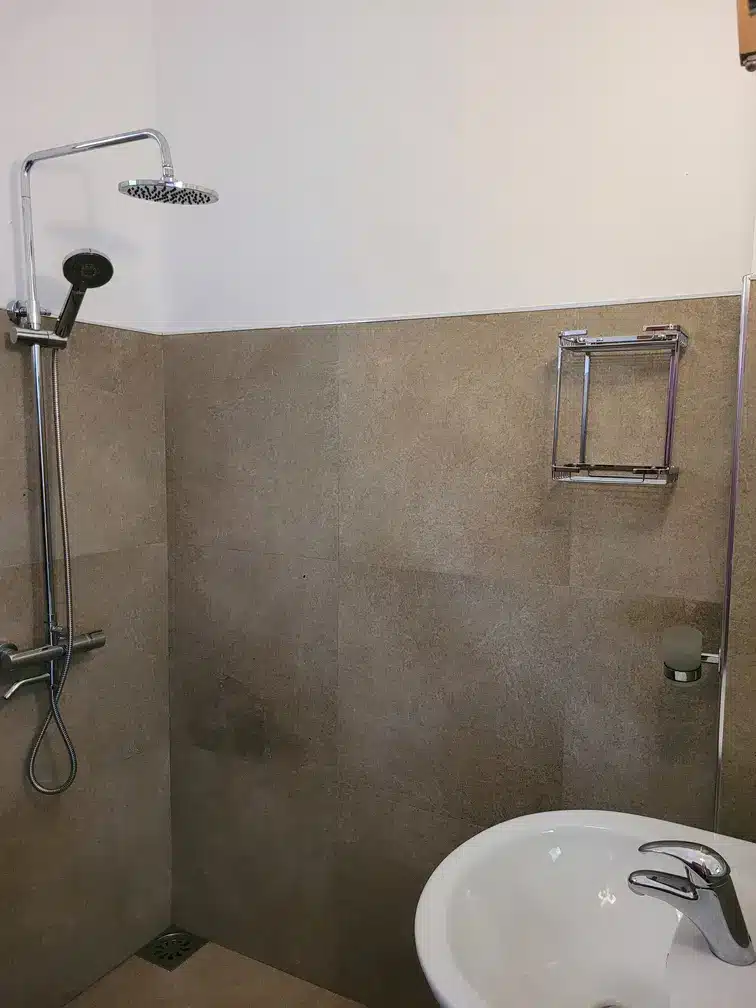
[564,297,739,601]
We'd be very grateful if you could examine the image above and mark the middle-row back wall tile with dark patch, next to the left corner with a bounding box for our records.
[171,547,337,767]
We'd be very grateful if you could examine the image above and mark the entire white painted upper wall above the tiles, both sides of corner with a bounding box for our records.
[0,0,756,331]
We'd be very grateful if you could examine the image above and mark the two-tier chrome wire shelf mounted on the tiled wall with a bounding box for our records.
[551,325,688,487]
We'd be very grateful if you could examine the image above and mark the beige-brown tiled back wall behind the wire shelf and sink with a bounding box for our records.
[165,297,738,1008]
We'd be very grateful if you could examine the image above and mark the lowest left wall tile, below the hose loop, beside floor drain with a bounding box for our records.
[0,748,170,1008]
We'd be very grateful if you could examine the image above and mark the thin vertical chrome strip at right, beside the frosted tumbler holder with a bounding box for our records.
[714,273,756,832]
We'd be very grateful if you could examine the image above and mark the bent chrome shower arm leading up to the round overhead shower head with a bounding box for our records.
[19,129,173,330]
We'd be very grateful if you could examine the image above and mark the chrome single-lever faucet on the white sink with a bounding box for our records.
[627,840,756,966]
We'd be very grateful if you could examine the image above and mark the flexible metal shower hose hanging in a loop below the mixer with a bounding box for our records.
[27,349,79,794]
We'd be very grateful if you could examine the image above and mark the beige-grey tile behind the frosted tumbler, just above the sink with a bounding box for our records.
[563,591,720,829]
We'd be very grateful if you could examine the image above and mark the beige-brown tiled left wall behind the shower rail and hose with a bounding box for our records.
[0,326,170,1008]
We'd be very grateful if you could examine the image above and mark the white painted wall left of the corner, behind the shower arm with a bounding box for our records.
[0,0,165,329]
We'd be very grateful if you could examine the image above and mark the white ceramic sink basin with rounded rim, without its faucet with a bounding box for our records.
[415,811,756,1008]
